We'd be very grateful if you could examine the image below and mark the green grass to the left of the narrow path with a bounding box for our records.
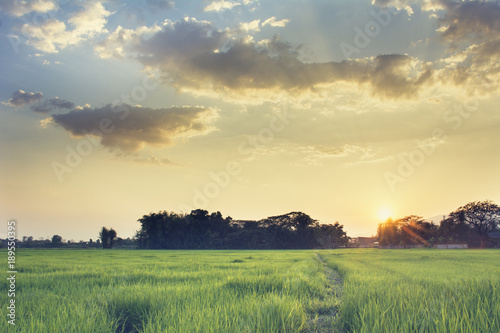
[0,250,338,333]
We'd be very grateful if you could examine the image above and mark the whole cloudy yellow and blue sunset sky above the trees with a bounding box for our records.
[0,0,500,240]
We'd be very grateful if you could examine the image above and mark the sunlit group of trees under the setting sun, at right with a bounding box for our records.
[377,200,500,248]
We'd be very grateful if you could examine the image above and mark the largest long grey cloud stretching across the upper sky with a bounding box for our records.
[100,19,431,98]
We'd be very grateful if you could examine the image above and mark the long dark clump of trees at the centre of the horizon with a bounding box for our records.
[136,209,349,249]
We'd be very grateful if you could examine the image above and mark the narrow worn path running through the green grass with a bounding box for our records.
[306,252,344,333]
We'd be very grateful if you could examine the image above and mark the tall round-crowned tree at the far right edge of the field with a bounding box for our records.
[450,200,500,248]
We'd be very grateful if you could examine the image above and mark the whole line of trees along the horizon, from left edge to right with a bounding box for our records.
[0,201,500,249]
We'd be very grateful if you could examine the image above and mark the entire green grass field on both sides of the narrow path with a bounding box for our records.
[0,249,500,333]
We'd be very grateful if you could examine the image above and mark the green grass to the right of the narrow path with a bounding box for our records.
[320,249,500,333]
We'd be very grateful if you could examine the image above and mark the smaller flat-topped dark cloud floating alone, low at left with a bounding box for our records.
[52,105,217,153]
